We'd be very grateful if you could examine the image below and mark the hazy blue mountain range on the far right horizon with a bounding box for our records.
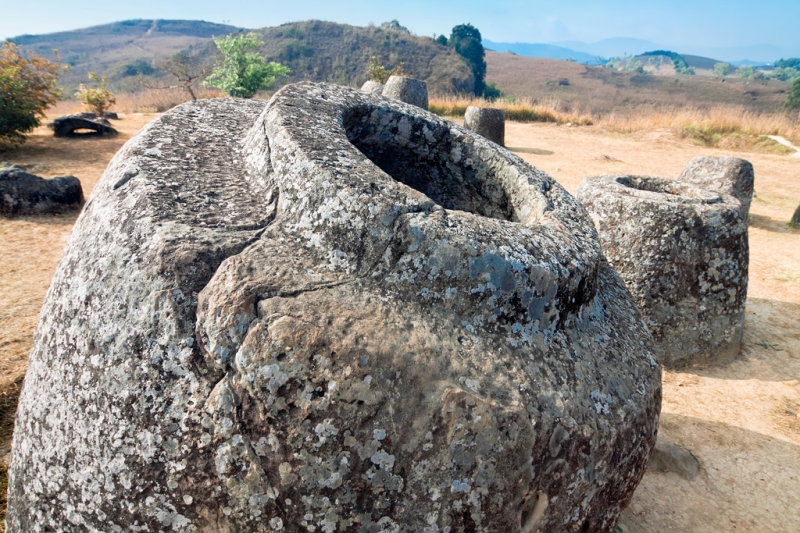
[483,37,800,66]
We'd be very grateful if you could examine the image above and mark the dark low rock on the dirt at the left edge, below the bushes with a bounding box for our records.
[0,166,83,215]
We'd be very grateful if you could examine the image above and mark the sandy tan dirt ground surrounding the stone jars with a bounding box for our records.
[0,111,800,533]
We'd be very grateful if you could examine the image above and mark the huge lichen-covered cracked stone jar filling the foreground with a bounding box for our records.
[8,83,661,532]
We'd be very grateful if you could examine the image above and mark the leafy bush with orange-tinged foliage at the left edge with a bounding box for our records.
[0,42,68,144]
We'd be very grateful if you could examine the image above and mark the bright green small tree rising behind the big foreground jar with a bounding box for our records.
[204,33,291,98]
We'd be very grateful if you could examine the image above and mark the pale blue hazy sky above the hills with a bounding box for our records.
[0,0,800,51]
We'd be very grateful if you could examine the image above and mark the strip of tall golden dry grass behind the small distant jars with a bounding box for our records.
[428,96,593,126]
